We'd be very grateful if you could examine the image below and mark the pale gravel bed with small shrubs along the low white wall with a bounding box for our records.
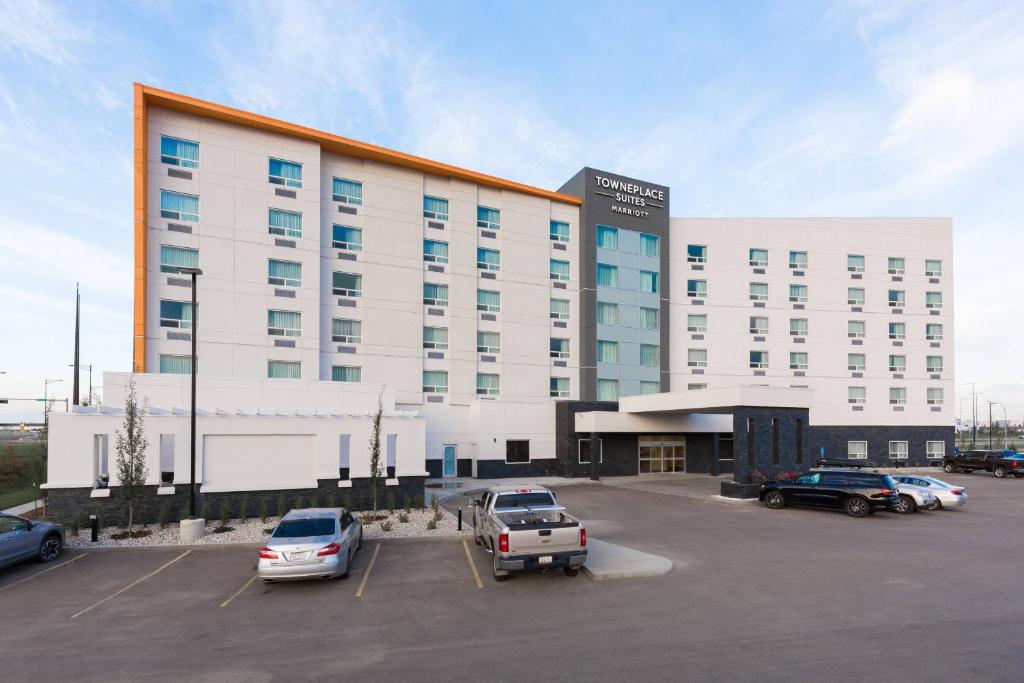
[67,509,472,548]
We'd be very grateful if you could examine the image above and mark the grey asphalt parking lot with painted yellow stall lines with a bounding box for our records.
[6,473,1024,681]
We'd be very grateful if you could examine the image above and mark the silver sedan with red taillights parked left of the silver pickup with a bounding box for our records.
[256,508,362,583]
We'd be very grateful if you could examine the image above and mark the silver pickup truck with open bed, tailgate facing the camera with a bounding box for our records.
[469,485,587,581]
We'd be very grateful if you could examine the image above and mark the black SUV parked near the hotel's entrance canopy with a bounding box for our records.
[760,468,900,517]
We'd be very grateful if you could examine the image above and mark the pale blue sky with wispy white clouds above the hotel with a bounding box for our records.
[0,0,1024,422]
